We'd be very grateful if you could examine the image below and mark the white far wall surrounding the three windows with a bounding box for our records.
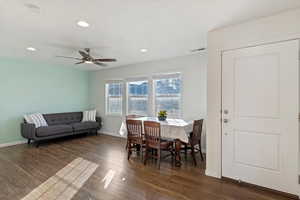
[90,54,207,138]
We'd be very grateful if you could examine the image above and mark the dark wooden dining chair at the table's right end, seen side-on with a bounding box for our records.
[184,119,204,166]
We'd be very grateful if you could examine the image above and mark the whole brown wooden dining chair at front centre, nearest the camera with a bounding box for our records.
[144,121,174,169]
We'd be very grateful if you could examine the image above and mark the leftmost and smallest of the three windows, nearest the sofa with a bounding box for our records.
[105,82,123,115]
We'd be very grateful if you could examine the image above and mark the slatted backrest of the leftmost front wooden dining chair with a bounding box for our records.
[126,119,143,140]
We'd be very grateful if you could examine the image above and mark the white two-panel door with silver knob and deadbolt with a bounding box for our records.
[222,40,299,194]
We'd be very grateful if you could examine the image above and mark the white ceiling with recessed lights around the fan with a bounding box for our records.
[0,0,300,69]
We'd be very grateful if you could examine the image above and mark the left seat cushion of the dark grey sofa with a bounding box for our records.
[36,125,73,137]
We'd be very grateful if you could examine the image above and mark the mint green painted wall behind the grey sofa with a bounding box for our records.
[0,58,89,144]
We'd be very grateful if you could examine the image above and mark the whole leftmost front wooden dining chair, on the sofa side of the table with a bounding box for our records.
[126,119,145,160]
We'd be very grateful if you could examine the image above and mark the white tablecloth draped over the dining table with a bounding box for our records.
[119,117,193,143]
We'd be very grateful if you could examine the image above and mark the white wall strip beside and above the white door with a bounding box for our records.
[206,9,300,177]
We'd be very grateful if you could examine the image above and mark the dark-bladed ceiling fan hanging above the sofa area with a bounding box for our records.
[56,48,117,67]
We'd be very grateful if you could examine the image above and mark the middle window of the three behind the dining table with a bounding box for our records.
[127,80,148,115]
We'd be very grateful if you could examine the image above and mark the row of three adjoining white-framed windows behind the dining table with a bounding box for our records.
[105,73,182,118]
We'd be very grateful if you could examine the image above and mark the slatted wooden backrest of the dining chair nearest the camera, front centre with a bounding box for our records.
[144,121,161,148]
